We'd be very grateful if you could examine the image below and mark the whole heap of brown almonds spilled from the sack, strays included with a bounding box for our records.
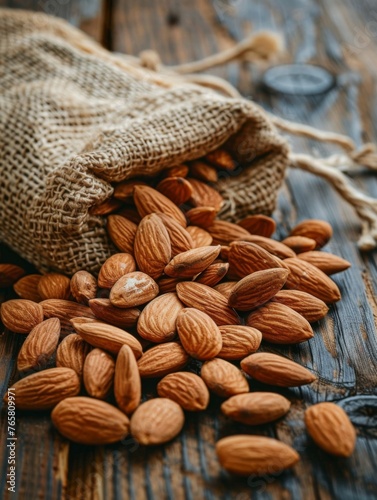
[0,150,355,475]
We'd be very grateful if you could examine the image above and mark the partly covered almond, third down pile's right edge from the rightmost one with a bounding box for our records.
[271,290,329,323]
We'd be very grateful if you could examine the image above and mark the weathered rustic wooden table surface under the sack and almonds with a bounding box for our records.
[0,0,377,500]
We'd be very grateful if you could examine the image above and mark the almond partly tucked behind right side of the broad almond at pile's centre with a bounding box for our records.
[217,325,262,361]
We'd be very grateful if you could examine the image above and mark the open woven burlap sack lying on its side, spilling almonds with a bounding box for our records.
[0,10,288,274]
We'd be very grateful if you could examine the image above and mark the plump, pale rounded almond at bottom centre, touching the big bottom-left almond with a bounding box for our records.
[131,398,185,446]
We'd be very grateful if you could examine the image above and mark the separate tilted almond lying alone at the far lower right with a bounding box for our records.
[305,402,356,457]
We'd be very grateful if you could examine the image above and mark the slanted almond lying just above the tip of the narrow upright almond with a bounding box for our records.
[71,318,143,358]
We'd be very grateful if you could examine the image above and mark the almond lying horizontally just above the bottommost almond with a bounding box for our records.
[221,392,291,425]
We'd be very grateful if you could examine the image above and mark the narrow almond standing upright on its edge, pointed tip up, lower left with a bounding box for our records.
[114,345,141,415]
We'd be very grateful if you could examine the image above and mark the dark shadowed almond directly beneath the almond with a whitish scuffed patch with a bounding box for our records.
[89,299,140,328]
